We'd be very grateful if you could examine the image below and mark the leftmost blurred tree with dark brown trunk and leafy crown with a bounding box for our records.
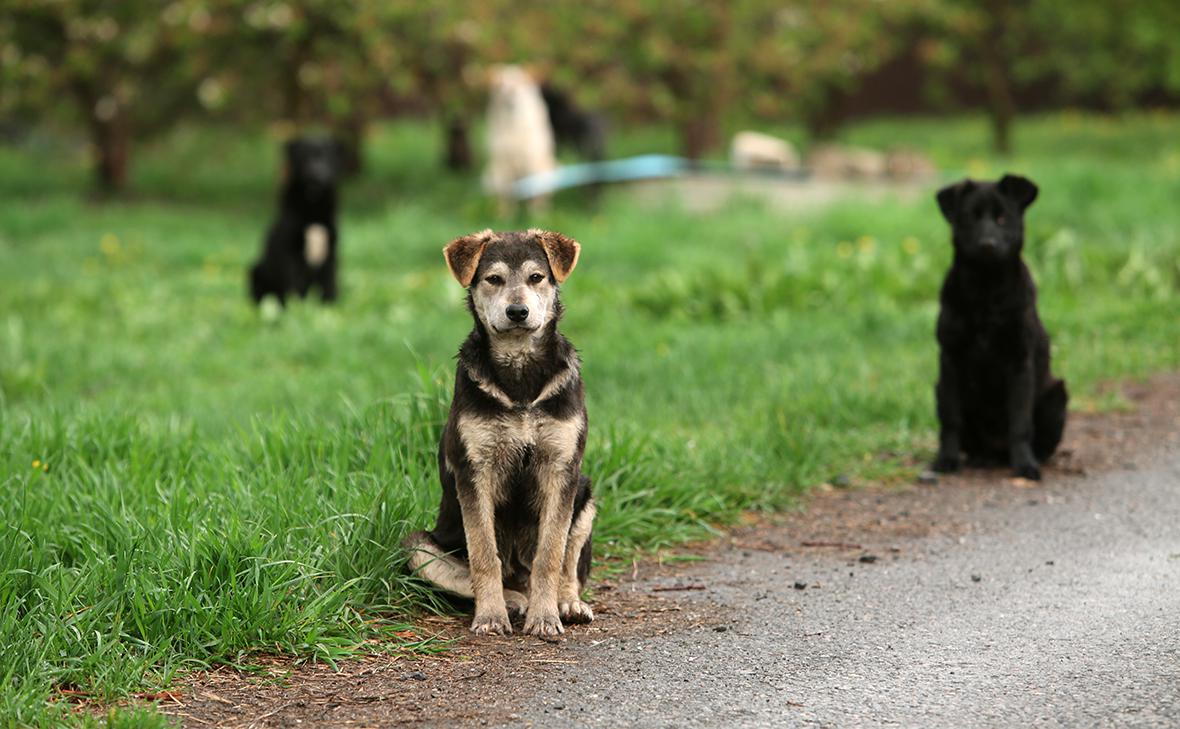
[0,0,211,192]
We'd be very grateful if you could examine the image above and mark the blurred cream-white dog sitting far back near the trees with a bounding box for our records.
[484,66,557,214]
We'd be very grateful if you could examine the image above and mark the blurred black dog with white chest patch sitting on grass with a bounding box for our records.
[250,139,341,304]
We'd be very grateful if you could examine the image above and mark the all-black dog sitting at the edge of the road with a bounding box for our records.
[933,169,1069,479]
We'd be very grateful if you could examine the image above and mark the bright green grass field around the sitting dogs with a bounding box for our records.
[0,114,1180,725]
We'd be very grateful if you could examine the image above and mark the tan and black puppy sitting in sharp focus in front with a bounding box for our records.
[404,230,596,636]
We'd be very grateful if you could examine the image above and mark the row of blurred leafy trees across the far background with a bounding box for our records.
[0,0,1180,190]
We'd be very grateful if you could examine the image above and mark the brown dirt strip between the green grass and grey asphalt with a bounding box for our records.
[80,375,1180,728]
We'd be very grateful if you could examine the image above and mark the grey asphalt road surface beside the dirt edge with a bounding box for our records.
[510,438,1180,727]
